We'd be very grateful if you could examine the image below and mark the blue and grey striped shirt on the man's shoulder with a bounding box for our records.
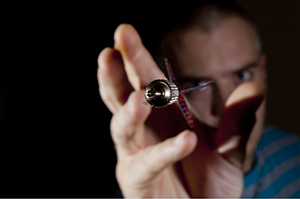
[242,126,300,198]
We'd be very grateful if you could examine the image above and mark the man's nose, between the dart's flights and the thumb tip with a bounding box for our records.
[211,82,235,118]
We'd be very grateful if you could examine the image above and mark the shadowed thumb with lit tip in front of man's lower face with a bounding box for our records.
[215,82,264,167]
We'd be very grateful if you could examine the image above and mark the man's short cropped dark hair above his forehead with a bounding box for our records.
[154,0,263,69]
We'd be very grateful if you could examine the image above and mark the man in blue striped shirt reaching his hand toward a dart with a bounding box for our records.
[98,1,300,197]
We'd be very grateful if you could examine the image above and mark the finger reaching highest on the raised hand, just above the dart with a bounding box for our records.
[114,24,166,91]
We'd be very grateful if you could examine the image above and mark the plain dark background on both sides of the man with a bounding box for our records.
[0,0,300,197]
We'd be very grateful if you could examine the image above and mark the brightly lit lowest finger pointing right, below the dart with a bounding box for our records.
[136,130,197,183]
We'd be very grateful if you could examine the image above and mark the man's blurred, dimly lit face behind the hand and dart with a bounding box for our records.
[166,17,266,127]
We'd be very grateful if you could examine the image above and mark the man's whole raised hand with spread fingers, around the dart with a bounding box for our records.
[98,24,262,197]
